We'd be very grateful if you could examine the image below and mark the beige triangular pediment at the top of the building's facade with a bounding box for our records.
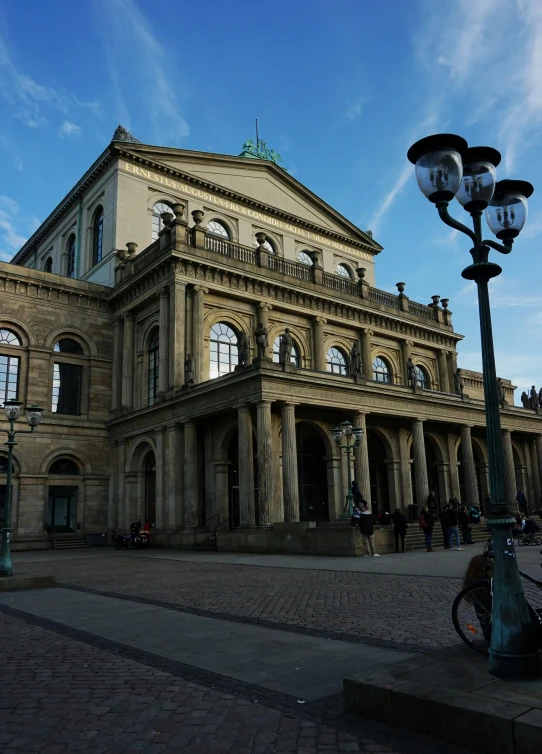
[119,144,382,254]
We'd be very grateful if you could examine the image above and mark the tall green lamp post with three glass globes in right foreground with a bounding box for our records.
[408,134,542,680]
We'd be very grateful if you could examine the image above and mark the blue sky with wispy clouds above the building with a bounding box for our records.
[0,0,542,402]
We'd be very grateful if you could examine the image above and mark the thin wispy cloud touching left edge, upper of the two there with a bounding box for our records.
[0,28,100,128]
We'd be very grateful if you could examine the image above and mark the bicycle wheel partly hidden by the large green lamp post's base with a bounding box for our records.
[452,579,492,654]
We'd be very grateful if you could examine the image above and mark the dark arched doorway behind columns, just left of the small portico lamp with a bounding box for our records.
[295,422,329,521]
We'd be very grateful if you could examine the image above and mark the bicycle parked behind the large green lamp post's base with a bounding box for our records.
[452,540,542,654]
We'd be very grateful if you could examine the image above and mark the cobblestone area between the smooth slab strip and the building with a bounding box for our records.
[17,552,460,651]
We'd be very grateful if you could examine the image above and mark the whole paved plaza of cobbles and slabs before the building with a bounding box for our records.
[0,547,540,754]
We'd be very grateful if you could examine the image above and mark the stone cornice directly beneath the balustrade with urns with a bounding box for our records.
[110,247,463,349]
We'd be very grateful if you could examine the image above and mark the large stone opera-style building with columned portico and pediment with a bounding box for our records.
[0,129,542,551]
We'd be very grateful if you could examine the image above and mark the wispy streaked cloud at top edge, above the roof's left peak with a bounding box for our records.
[100,0,190,146]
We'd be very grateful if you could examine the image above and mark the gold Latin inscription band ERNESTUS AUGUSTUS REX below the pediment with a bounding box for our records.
[124,162,373,262]
